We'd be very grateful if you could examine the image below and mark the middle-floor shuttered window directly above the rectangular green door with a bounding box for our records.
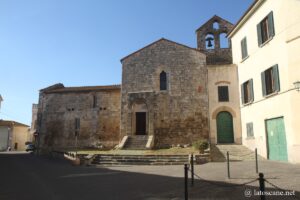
[261,64,280,96]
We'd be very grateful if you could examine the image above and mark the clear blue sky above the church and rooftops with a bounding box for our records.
[0,0,253,125]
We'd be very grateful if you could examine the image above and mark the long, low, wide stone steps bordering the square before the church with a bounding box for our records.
[91,154,208,166]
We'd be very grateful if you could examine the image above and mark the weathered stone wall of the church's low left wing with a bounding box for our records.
[38,88,120,149]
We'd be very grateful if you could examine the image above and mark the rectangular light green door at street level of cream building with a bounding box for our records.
[266,117,288,161]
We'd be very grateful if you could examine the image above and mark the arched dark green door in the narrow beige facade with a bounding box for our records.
[217,112,234,143]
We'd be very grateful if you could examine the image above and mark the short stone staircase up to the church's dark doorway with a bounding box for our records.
[123,135,148,150]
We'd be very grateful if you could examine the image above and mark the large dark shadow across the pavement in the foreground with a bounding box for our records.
[0,154,300,200]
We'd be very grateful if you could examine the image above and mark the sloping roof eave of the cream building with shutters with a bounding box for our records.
[227,0,265,38]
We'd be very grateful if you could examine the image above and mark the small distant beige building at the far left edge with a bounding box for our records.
[0,120,30,151]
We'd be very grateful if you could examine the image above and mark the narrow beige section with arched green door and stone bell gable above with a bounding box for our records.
[196,15,241,144]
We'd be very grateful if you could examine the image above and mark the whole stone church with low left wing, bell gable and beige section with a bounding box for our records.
[37,16,241,149]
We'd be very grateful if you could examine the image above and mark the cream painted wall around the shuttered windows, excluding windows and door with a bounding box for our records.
[231,0,300,163]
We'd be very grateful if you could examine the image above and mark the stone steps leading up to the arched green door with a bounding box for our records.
[210,144,264,162]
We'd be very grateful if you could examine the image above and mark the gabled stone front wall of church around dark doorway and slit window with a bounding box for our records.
[121,39,208,147]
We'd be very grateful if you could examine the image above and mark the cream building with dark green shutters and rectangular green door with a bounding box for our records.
[229,0,300,163]
